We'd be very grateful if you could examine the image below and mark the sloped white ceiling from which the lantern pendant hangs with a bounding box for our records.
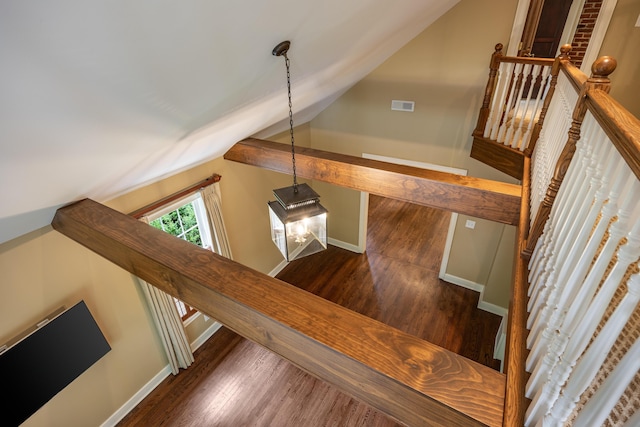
[0,0,459,242]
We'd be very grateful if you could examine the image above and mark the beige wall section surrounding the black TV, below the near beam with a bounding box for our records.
[0,227,166,427]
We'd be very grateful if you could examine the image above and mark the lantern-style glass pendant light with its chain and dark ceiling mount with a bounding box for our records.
[268,41,327,261]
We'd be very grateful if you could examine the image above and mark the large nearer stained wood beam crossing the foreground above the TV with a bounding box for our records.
[52,199,505,426]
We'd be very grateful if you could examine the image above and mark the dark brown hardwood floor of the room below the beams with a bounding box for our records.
[119,196,501,427]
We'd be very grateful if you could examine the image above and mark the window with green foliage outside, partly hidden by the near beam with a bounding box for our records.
[149,194,213,322]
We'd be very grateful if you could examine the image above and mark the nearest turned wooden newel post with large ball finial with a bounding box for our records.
[522,56,617,257]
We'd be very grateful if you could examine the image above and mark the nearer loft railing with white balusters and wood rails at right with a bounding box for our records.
[504,47,640,426]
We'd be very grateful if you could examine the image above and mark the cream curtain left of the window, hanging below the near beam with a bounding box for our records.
[138,216,194,375]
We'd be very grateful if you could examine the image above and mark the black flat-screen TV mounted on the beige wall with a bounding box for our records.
[0,301,111,426]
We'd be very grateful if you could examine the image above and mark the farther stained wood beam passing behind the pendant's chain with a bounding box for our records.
[224,138,522,225]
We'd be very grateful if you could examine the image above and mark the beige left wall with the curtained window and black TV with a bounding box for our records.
[0,138,296,427]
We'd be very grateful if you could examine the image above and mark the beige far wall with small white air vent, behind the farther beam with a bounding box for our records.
[311,0,517,307]
